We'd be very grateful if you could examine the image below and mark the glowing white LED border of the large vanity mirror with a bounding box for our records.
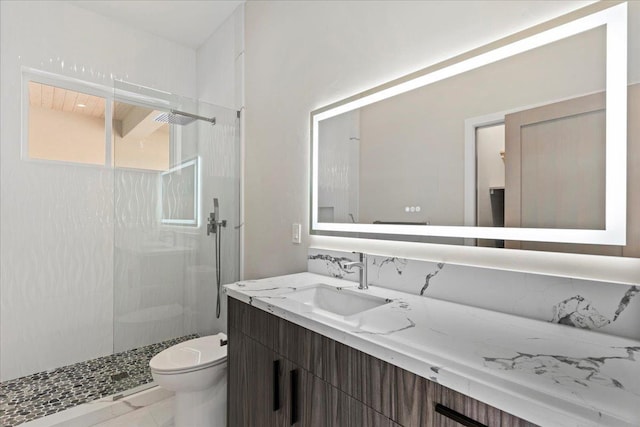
[311,2,627,245]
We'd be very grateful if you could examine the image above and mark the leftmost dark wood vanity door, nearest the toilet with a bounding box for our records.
[227,327,289,427]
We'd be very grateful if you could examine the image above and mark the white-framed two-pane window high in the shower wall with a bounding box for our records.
[22,72,171,172]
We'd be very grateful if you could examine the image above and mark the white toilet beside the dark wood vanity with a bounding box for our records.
[149,333,227,427]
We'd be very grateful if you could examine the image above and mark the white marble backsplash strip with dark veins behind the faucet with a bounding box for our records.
[308,248,640,340]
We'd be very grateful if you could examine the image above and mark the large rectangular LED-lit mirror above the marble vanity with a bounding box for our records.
[311,4,637,247]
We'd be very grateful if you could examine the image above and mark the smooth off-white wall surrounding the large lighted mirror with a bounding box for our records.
[245,1,640,283]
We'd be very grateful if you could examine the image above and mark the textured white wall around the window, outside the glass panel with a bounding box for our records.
[0,1,196,380]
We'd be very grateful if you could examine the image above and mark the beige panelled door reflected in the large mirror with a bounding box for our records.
[505,85,639,256]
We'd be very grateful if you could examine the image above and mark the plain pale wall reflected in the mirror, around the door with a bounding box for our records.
[352,28,605,225]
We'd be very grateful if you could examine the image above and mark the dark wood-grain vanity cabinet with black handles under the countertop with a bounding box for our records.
[227,298,534,427]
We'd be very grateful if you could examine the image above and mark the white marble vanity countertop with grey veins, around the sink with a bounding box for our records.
[225,273,640,426]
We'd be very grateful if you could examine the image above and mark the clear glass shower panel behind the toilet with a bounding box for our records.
[112,82,240,364]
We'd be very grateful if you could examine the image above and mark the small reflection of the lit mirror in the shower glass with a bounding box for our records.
[160,158,199,226]
